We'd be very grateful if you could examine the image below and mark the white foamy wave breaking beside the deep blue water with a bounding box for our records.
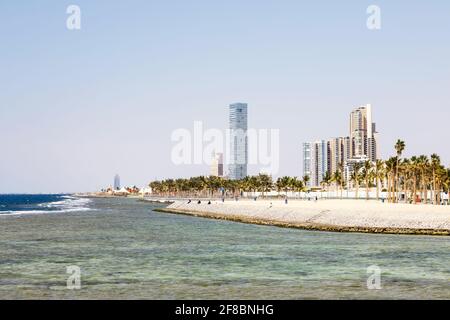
[0,196,94,216]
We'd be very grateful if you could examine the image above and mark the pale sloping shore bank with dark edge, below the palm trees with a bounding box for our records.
[159,200,450,236]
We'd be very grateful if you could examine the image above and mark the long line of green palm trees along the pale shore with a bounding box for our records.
[150,140,450,204]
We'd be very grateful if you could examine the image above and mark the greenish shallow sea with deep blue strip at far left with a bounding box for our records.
[0,195,450,299]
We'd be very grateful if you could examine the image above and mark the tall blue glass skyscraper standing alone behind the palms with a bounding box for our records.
[228,103,248,180]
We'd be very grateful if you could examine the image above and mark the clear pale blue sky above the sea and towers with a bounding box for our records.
[0,0,450,193]
